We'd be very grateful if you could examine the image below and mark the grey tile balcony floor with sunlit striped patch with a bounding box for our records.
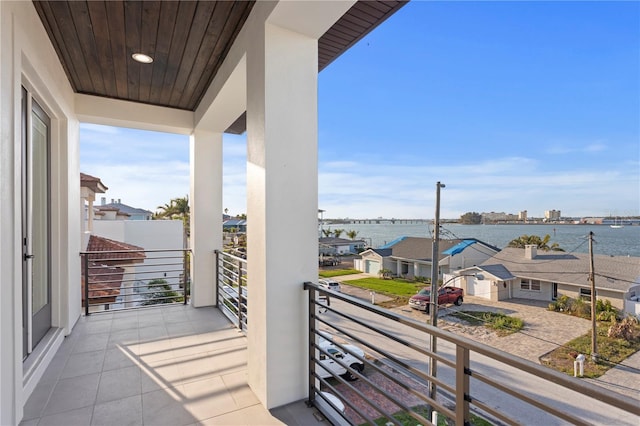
[21,306,328,426]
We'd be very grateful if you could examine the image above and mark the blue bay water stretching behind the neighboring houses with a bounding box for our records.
[324,223,640,257]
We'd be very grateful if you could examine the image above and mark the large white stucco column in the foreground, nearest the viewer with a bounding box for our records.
[247,23,318,408]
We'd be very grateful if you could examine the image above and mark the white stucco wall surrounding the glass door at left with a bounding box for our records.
[0,1,81,424]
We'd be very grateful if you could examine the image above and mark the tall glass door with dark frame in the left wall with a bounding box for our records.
[22,88,51,358]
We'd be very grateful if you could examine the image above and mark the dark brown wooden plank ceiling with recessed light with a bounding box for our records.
[33,0,406,133]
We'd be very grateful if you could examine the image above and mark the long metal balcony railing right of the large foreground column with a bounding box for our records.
[304,282,640,425]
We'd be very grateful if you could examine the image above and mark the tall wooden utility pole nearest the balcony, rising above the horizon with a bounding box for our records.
[429,182,444,424]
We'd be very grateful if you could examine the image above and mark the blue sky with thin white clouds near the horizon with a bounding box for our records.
[81,1,640,218]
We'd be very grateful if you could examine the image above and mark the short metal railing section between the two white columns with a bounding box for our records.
[215,250,247,333]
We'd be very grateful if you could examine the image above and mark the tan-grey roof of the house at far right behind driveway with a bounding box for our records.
[480,247,640,291]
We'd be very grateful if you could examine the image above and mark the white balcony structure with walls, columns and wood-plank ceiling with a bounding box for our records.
[0,1,404,425]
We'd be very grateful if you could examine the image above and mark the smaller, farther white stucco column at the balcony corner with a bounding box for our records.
[189,129,222,307]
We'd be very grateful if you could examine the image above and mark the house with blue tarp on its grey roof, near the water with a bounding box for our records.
[354,237,500,279]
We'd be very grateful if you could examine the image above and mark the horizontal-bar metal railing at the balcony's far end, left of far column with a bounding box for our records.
[80,249,191,315]
